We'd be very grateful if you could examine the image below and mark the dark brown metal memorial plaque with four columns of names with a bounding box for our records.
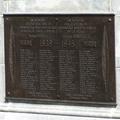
[4,14,116,106]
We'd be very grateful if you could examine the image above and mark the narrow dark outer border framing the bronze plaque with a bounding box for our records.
[3,13,117,107]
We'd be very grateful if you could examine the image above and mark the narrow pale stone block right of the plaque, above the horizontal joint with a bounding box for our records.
[115,16,120,67]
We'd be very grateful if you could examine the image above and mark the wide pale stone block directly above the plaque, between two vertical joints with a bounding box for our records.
[8,0,109,13]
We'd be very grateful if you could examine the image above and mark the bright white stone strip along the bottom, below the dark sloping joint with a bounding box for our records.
[0,112,119,120]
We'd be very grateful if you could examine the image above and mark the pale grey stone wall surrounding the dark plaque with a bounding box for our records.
[0,0,120,120]
